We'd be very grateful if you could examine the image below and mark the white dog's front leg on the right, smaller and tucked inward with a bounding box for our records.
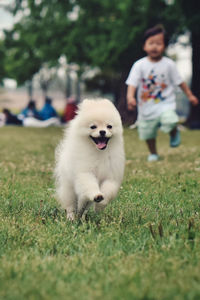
[94,180,119,212]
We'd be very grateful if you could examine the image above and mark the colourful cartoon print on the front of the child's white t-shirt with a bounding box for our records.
[141,69,167,103]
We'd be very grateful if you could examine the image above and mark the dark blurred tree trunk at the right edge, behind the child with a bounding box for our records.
[175,0,200,128]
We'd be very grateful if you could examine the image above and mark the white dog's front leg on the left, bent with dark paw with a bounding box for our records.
[75,173,104,216]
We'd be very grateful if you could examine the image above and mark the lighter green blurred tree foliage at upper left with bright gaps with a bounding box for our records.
[4,0,72,96]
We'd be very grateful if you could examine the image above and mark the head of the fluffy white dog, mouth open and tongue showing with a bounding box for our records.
[74,100,122,150]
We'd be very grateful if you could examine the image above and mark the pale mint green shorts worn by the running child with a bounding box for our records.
[138,110,178,140]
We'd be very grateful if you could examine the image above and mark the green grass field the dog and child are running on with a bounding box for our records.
[0,127,200,300]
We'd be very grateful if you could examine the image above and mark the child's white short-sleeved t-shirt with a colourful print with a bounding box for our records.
[126,57,183,120]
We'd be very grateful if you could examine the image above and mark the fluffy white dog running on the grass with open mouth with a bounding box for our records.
[55,99,124,220]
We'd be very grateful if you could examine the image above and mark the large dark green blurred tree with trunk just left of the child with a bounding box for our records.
[66,0,181,123]
